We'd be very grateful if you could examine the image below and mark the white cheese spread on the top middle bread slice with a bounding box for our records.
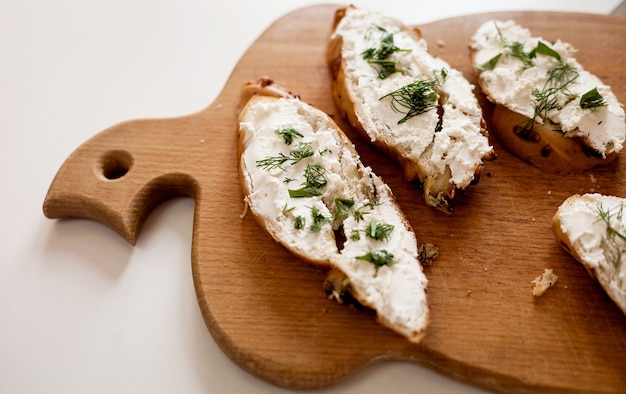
[333,8,492,188]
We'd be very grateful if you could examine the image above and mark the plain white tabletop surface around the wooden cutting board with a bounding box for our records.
[0,0,619,394]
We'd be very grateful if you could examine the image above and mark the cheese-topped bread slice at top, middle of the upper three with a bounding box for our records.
[327,6,495,213]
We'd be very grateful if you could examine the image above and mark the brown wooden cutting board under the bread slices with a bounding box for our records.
[44,5,626,392]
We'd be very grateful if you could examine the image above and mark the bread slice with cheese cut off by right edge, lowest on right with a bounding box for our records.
[552,193,626,314]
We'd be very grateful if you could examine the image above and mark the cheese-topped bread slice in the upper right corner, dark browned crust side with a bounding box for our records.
[470,20,626,175]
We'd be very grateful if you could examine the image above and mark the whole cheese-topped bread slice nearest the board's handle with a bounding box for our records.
[238,80,429,342]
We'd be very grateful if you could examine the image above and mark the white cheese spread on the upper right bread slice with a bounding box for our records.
[472,20,626,156]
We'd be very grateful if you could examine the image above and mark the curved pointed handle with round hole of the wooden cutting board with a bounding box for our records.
[43,108,213,244]
